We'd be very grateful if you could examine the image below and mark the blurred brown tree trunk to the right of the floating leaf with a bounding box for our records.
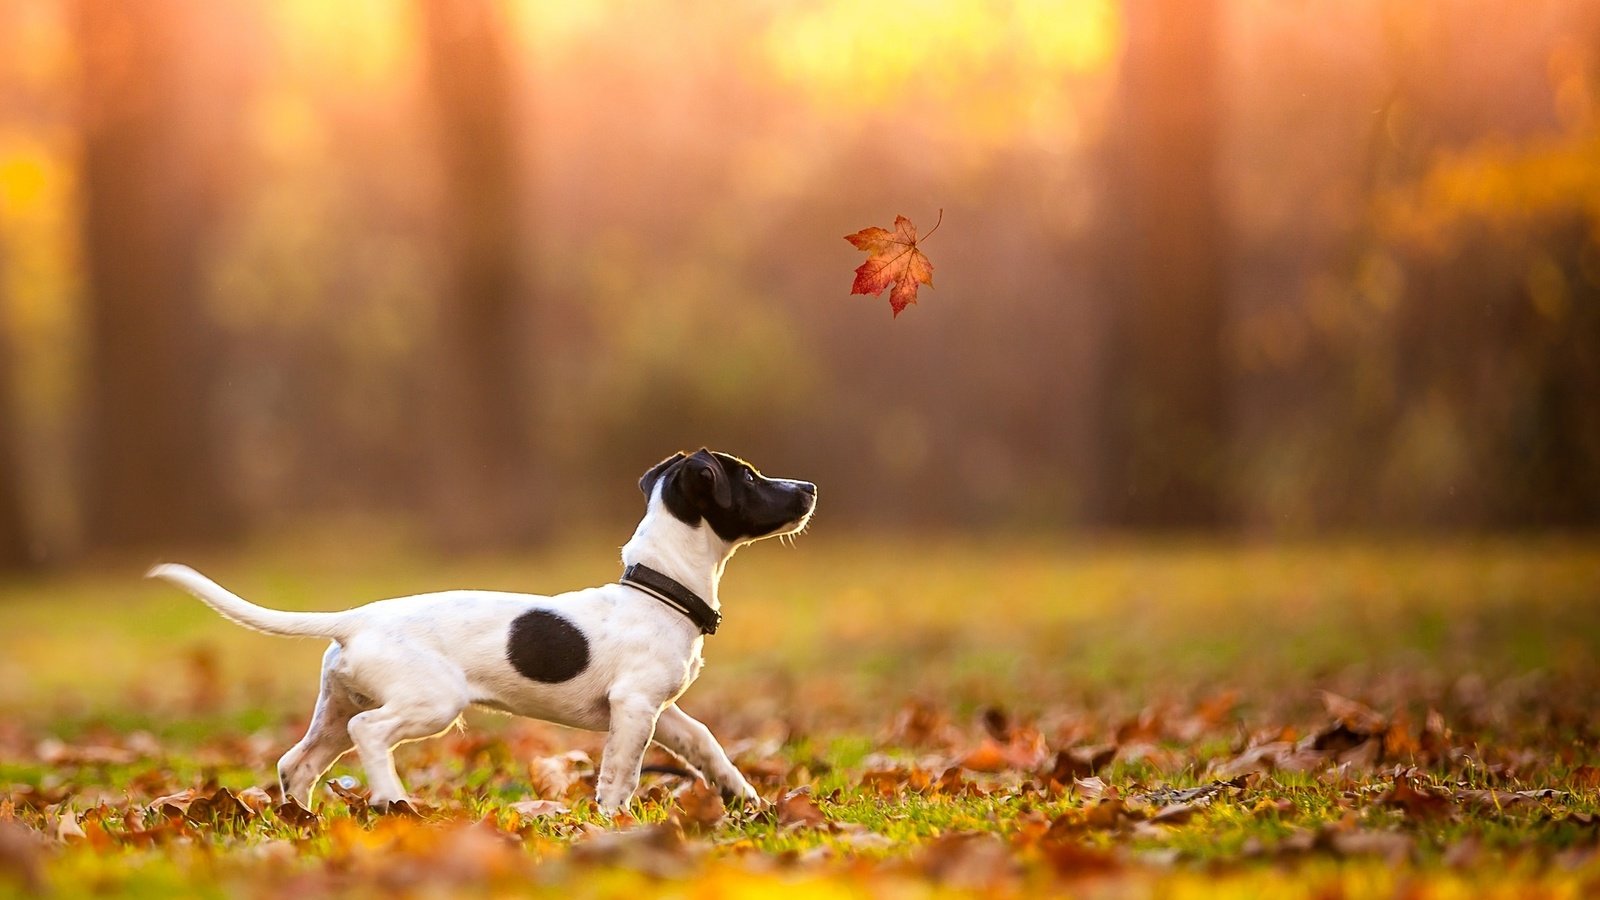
[1098,0,1229,528]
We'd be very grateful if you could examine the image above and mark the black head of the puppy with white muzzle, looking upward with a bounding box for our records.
[638,448,816,544]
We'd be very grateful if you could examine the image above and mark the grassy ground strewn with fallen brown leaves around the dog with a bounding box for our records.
[0,528,1600,897]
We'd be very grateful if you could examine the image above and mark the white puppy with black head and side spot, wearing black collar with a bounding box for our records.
[147,448,816,815]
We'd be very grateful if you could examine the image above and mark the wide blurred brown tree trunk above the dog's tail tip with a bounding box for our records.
[75,0,238,546]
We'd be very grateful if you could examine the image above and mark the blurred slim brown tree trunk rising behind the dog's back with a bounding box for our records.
[419,0,547,546]
